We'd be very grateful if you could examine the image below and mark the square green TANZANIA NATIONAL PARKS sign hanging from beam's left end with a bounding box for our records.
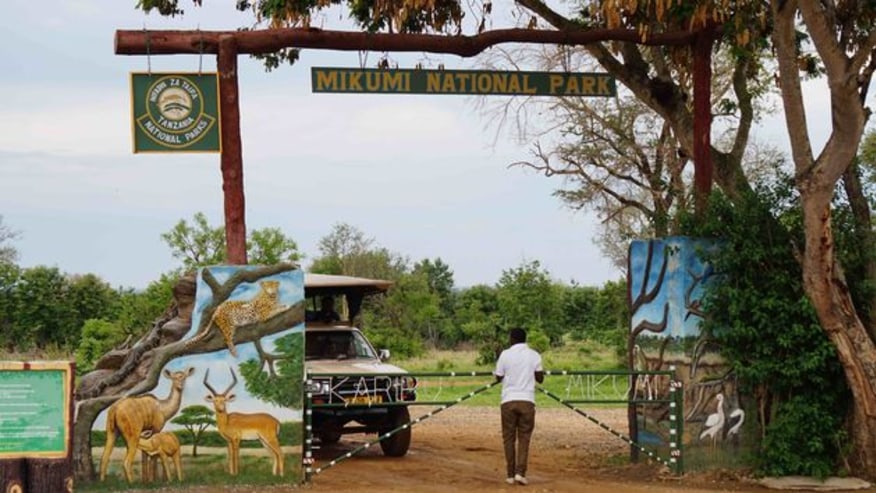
[131,73,222,153]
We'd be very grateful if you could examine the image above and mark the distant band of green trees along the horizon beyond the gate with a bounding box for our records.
[0,258,629,368]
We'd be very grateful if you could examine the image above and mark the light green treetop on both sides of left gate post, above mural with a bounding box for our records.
[161,212,301,271]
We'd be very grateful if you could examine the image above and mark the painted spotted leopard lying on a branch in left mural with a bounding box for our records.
[186,281,289,357]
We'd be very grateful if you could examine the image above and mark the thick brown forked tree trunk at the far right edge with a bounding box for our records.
[771,0,876,478]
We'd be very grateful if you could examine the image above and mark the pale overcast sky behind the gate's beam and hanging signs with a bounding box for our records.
[0,0,836,288]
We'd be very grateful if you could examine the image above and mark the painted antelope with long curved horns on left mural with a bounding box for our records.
[204,369,283,476]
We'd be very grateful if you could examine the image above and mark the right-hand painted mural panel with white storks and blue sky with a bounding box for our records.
[629,237,750,469]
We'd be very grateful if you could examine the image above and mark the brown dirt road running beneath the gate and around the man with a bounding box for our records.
[118,407,876,493]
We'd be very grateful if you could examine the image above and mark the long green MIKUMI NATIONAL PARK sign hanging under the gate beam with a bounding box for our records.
[311,67,617,97]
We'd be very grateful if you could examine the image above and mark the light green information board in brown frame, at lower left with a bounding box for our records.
[0,362,72,459]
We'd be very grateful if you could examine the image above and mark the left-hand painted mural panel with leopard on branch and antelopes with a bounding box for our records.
[92,266,304,484]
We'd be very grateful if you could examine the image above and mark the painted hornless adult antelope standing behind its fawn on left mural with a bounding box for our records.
[100,367,195,483]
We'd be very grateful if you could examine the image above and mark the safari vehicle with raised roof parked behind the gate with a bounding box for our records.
[304,273,417,457]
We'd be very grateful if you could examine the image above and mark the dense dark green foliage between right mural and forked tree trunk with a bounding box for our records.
[692,180,849,477]
